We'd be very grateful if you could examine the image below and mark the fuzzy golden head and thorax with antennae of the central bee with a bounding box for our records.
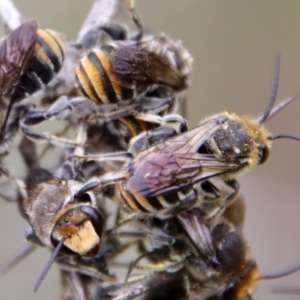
[206,55,300,167]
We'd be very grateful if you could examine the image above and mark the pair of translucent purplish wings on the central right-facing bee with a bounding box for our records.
[126,118,241,197]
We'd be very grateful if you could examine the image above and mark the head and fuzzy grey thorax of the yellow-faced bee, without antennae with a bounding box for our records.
[22,169,104,256]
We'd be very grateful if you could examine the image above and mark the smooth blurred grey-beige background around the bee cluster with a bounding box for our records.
[0,0,300,300]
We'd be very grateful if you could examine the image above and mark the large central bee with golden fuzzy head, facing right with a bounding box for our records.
[72,54,300,220]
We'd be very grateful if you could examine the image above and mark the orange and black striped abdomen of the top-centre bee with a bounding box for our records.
[76,48,134,104]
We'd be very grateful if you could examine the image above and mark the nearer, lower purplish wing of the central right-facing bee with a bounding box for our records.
[126,152,240,197]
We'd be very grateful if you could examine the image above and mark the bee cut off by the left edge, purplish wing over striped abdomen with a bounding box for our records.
[0,20,65,143]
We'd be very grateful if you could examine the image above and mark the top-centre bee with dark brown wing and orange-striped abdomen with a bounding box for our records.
[76,0,192,119]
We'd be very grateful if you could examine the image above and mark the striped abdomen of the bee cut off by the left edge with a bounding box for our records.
[13,29,65,101]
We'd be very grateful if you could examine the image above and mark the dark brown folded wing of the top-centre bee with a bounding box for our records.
[110,44,185,90]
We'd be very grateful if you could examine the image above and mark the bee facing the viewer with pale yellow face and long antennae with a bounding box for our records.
[0,123,112,291]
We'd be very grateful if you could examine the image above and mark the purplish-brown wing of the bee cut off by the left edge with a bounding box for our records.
[0,20,38,95]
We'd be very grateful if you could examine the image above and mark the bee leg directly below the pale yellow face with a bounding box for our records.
[56,255,115,282]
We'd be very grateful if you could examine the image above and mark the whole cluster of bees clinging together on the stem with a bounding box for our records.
[0,0,300,300]
